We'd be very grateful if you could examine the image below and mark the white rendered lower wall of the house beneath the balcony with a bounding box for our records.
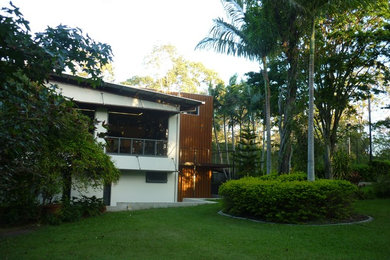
[111,171,176,206]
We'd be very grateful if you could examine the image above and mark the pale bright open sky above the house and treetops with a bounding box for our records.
[5,0,259,82]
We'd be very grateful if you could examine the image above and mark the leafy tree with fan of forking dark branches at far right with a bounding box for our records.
[315,1,390,178]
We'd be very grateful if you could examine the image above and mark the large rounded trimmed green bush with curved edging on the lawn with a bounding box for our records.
[219,178,357,223]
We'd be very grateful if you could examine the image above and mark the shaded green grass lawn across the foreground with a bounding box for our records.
[0,199,390,260]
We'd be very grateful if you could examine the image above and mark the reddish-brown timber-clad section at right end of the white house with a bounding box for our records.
[178,93,213,201]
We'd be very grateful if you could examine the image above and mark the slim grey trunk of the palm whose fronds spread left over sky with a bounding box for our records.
[262,56,272,174]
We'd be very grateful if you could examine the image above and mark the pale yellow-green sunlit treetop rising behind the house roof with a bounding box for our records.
[123,45,222,93]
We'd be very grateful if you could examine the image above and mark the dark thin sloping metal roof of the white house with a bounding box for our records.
[50,74,204,111]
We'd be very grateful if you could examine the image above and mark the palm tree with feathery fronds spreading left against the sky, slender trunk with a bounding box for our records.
[195,0,277,174]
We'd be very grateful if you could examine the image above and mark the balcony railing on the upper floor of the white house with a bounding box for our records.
[105,136,168,156]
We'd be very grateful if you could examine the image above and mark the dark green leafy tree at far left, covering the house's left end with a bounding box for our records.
[0,4,119,221]
